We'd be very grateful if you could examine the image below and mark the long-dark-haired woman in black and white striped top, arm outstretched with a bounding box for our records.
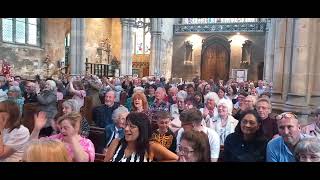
[104,112,178,162]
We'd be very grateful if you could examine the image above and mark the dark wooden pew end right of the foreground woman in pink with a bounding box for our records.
[88,126,106,154]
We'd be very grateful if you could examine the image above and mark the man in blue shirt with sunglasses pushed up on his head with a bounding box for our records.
[267,112,307,162]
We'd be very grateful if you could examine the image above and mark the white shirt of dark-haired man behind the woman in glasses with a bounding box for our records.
[176,127,220,159]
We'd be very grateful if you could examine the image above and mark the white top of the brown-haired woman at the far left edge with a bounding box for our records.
[0,125,30,162]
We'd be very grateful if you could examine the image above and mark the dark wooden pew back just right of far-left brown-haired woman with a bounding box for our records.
[22,103,40,133]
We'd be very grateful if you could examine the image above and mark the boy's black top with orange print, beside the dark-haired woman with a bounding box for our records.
[152,129,177,153]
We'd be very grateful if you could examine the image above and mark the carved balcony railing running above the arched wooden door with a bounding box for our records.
[173,22,267,34]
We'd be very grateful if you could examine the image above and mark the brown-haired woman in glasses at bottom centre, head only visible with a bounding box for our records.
[178,130,211,162]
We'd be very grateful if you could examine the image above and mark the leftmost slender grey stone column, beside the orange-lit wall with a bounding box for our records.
[70,18,85,75]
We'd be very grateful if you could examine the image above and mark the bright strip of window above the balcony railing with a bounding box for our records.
[182,18,258,24]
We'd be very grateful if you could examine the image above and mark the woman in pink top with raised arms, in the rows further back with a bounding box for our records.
[69,78,86,108]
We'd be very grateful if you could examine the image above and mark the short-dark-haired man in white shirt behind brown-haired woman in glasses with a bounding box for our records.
[177,108,220,162]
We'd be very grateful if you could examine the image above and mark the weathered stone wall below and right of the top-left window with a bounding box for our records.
[0,18,70,78]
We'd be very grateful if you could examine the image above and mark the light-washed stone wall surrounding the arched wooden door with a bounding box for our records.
[172,33,265,81]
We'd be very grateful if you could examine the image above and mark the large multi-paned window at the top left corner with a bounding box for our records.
[0,18,40,46]
